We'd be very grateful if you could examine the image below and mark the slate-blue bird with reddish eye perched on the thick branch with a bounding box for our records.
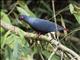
[19,15,65,34]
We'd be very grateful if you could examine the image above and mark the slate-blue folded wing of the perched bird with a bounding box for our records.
[32,19,55,32]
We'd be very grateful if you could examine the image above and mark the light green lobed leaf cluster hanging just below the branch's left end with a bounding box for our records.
[1,30,25,48]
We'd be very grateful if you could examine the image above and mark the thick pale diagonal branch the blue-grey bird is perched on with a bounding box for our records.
[0,20,80,60]
